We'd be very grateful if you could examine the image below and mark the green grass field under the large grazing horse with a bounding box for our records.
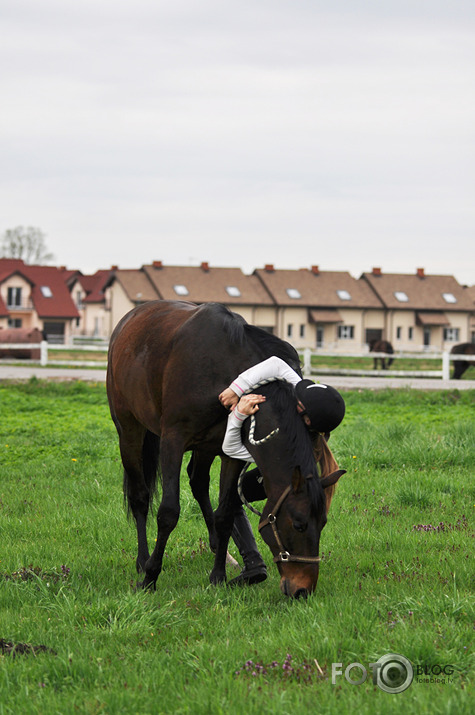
[0,380,475,715]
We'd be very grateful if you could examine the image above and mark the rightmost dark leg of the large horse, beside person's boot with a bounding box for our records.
[209,457,243,584]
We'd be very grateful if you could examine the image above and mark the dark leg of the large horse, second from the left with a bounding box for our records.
[142,436,183,588]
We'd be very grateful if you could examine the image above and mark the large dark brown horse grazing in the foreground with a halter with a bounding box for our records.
[106,301,344,597]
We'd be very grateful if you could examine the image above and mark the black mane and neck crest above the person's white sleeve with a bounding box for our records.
[206,303,302,376]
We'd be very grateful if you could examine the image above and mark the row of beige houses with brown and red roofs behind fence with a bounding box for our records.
[0,259,475,352]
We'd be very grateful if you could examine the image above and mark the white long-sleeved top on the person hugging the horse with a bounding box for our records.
[223,356,302,462]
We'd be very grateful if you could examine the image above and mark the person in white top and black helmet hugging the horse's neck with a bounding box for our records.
[219,356,345,585]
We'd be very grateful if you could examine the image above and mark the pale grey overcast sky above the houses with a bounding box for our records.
[0,0,475,285]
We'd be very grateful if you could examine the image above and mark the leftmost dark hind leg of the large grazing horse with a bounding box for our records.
[119,423,151,571]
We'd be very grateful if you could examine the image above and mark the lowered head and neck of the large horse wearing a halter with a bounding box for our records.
[245,383,344,597]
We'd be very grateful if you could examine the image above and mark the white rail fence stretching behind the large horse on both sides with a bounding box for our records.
[0,340,475,380]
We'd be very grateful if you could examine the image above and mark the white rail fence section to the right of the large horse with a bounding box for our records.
[299,348,475,380]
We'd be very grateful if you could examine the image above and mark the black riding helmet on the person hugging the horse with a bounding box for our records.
[295,380,345,432]
